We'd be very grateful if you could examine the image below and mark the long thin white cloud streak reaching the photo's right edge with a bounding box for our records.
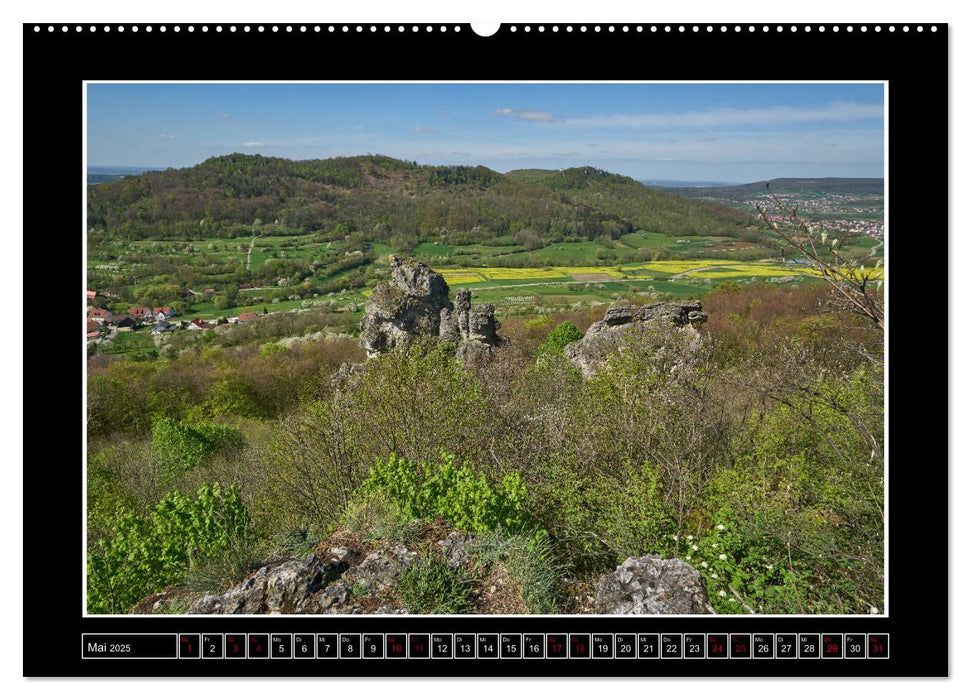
[561,102,883,129]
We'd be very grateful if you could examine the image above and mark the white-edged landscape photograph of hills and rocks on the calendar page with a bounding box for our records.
[85,82,889,616]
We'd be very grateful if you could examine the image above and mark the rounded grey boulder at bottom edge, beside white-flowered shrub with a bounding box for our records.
[595,554,715,615]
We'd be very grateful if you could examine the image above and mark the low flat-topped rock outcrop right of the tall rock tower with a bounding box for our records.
[564,301,708,377]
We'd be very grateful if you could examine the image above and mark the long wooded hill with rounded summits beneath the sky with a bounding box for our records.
[88,154,751,249]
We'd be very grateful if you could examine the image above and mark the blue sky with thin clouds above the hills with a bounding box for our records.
[87,83,884,182]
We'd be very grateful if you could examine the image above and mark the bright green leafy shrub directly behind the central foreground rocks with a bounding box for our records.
[362,454,529,532]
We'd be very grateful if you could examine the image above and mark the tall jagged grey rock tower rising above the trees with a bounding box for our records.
[360,255,501,359]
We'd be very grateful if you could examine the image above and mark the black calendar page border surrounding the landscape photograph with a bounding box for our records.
[23,23,950,676]
